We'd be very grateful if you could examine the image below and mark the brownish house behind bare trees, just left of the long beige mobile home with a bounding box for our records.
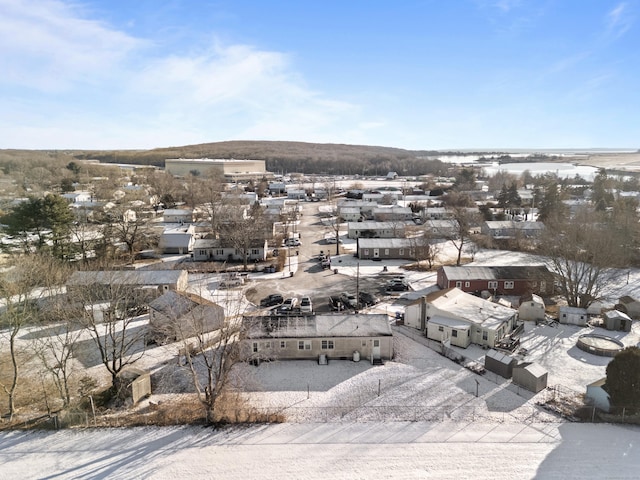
[149,291,224,342]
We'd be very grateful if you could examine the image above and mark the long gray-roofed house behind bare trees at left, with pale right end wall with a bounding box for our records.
[66,270,188,300]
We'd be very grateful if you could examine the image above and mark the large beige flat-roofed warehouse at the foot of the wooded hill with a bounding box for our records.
[164,158,267,180]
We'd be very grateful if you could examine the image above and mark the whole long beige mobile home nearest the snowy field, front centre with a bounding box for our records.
[244,314,393,363]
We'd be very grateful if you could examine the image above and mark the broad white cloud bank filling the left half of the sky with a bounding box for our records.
[0,0,368,148]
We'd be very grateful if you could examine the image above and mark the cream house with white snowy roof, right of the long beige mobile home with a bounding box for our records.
[404,288,518,348]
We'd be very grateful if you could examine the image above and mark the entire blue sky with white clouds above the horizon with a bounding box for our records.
[0,0,640,149]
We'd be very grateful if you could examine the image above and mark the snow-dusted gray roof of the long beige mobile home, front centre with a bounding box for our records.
[249,313,392,338]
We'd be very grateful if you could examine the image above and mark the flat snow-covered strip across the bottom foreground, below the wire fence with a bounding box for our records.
[0,422,640,480]
